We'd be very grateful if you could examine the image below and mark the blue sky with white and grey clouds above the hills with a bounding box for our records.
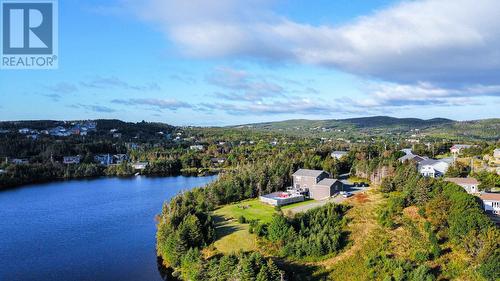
[0,0,500,126]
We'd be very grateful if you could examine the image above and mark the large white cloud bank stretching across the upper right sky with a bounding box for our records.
[125,0,500,84]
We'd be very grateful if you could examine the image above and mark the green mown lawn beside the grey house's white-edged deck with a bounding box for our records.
[214,199,276,222]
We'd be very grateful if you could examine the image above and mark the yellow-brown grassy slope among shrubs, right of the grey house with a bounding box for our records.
[315,190,482,280]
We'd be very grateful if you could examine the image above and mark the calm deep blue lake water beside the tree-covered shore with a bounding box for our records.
[0,176,215,281]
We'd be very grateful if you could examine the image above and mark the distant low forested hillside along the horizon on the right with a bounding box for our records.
[234,116,500,140]
